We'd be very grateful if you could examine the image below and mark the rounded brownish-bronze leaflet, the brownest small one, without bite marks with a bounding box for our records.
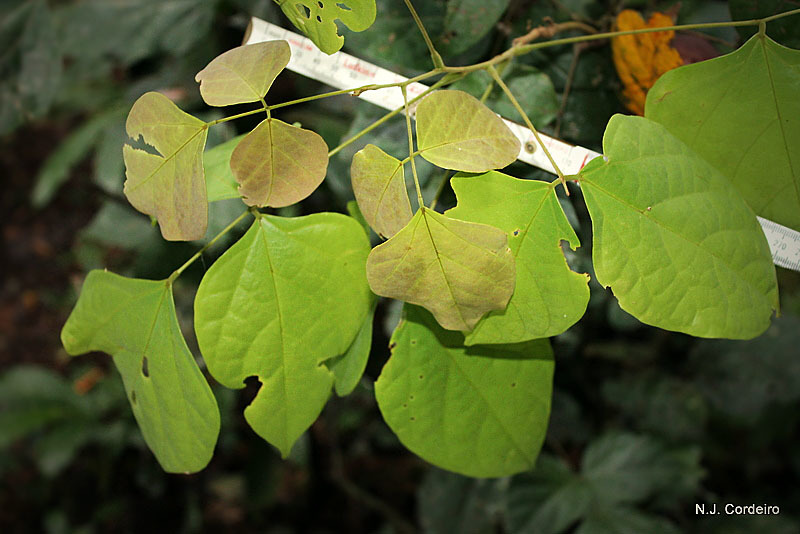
[231,119,328,208]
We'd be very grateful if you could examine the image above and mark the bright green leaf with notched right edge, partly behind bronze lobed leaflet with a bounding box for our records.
[446,171,589,345]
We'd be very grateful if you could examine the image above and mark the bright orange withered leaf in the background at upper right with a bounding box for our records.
[611,9,683,115]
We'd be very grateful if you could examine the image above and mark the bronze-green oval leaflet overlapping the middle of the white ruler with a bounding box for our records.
[417,90,520,172]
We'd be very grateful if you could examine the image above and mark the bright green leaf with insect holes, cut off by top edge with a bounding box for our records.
[278,0,376,54]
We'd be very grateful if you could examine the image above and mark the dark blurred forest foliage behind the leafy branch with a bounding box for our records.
[0,0,800,534]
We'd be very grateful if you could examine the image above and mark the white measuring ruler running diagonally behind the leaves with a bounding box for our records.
[244,17,800,271]
